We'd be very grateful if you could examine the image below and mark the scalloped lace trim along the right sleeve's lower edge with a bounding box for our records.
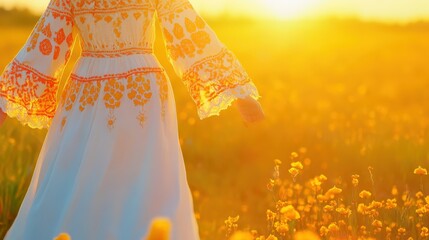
[198,81,261,120]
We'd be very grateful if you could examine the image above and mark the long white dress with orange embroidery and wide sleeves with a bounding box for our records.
[0,0,260,240]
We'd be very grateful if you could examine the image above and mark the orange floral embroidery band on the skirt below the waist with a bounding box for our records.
[57,68,166,129]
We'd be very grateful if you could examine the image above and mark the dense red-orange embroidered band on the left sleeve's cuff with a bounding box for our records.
[0,59,58,118]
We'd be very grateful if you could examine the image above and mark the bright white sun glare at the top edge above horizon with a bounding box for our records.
[264,0,320,19]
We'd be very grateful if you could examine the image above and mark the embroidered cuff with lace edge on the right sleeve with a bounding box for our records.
[183,48,261,119]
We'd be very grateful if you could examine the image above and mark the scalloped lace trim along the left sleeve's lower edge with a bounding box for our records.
[0,97,52,129]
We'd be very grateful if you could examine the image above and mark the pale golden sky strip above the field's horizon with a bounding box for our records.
[0,0,429,22]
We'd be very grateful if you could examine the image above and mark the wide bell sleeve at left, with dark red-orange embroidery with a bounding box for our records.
[0,0,76,129]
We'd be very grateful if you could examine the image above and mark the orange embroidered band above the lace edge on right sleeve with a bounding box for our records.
[183,48,251,107]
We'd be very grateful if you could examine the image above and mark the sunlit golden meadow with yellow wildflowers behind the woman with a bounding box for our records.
[0,15,429,240]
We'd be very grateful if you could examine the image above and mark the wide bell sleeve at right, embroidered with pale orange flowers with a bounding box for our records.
[154,0,261,119]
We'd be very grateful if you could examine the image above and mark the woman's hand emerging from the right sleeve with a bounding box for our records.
[235,96,265,123]
